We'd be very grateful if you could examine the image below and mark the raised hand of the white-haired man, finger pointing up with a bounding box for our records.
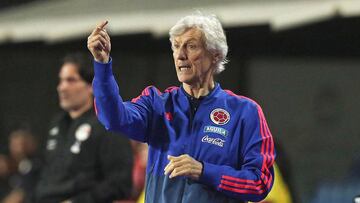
[87,21,111,63]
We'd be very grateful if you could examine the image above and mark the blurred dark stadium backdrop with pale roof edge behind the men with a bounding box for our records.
[0,0,360,202]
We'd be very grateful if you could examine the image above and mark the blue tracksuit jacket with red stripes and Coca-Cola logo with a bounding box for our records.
[93,58,275,203]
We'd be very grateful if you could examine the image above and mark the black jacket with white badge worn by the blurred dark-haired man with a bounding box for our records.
[36,110,133,203]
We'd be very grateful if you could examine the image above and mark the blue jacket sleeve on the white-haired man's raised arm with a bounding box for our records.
[93,60,152,142]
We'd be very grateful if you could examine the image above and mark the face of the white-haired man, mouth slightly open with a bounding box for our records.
[172,28,215,85]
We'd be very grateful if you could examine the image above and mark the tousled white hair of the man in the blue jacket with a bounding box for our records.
[169,11,228,74]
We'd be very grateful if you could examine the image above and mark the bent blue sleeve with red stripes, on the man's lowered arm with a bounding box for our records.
[199,105,275,202]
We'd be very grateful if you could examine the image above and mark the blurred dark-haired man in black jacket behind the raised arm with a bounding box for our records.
[35,53,133,203]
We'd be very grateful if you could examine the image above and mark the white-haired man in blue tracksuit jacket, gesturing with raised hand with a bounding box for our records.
[88,13,275,203]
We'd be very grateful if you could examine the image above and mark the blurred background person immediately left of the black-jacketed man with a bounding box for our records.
[3,129,42,203]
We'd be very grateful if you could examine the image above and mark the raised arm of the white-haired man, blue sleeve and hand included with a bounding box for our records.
[88,21,152,142]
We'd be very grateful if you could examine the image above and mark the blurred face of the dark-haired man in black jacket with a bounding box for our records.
[57,63,92,112]
